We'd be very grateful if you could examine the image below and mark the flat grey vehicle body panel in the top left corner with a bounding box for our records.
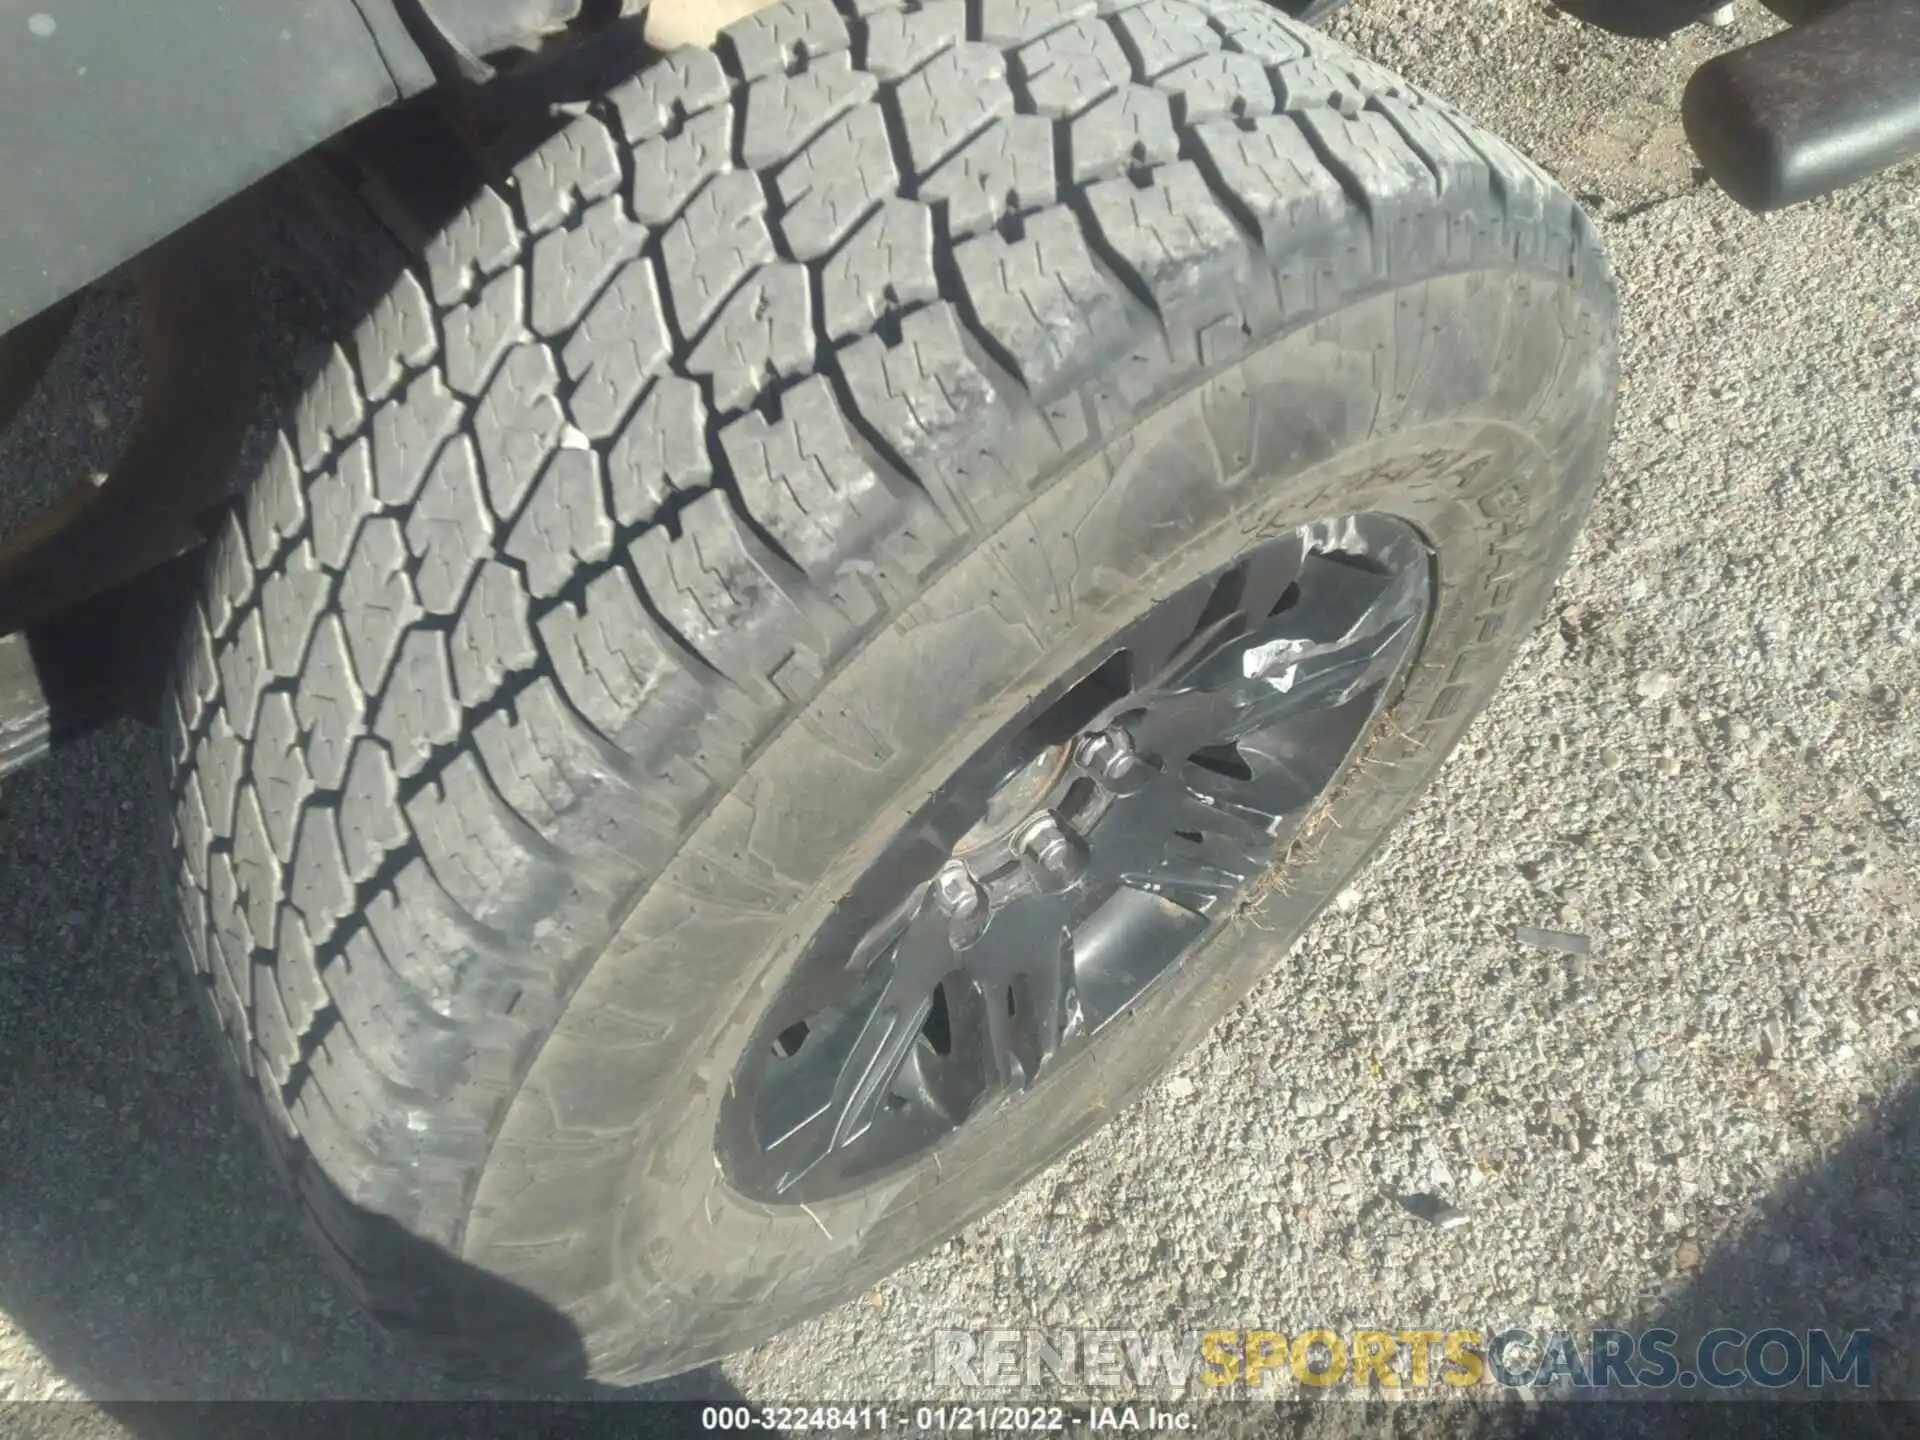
[0,0,580,332]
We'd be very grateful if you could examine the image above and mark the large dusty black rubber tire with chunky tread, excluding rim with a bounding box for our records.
[169,0,1615,1380]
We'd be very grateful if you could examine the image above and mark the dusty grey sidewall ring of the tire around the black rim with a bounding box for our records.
[465,264,1611,1379]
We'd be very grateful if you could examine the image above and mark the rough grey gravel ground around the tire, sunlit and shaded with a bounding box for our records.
[0,0,1920,1436]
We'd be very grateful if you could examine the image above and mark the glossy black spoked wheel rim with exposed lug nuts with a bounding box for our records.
[716,515,1432,1204]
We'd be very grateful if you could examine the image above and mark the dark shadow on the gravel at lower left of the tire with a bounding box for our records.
[0,724,756,1440]
